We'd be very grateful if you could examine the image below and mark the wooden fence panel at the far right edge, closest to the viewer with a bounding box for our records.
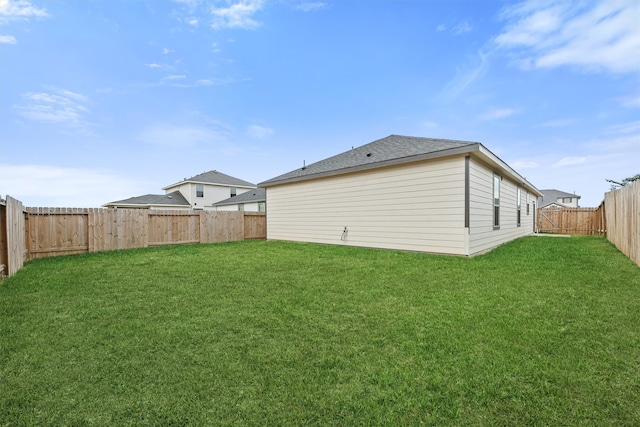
[604,181,640,266]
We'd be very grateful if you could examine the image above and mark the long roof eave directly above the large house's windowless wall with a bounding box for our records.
[258,142,482,187]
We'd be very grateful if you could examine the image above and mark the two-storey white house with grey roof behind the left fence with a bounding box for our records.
[102,170,256,210]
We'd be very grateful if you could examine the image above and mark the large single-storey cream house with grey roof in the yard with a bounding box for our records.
[258,135,542,256]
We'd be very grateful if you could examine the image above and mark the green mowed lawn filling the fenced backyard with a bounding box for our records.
[0,237,640,426]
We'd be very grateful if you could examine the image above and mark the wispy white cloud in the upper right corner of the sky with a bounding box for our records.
[494,0,640,73]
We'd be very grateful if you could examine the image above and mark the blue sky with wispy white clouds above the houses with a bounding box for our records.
[0,0,640,207]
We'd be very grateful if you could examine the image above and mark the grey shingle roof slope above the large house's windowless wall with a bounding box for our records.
[258,135,480,186]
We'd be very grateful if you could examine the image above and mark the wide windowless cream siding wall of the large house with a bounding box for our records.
[267,156,467,255]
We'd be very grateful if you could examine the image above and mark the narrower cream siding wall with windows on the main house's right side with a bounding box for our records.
[468,158,536,255]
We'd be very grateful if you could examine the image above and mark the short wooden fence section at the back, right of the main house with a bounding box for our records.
[537,203,607,236]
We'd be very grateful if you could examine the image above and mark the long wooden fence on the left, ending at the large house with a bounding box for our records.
[0,201,266,275]
